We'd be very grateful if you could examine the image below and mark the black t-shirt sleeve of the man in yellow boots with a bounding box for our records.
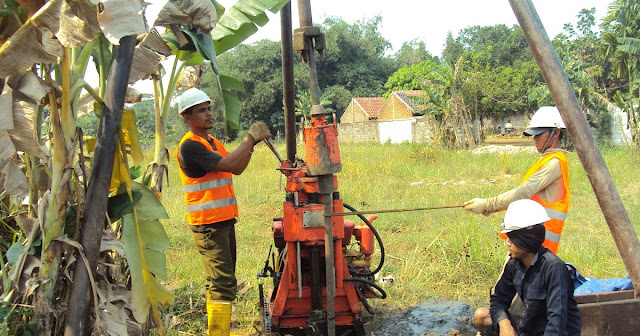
[178,137,222,178]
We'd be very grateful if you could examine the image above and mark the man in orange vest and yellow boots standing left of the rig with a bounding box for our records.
[175,88,271,336]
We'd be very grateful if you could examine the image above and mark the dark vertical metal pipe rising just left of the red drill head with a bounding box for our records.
[280,2,296,162]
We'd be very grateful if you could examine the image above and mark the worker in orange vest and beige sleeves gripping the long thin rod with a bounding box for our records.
[464,106,570,253]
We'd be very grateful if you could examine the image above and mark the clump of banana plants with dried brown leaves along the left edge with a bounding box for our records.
[0,0,287,335]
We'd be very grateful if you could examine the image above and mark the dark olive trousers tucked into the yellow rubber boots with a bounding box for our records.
[192,223,238,301]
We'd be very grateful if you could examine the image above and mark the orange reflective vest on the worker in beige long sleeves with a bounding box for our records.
[521,152,571,253]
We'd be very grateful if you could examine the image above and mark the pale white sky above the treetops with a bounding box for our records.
[134,0,610,93]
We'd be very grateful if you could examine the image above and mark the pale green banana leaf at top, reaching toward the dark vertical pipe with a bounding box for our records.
[211,0,289,55]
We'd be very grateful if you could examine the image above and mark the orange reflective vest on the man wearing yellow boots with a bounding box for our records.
[175,132,238,225]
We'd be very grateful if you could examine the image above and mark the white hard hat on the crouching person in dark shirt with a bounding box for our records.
[500,199,551,233]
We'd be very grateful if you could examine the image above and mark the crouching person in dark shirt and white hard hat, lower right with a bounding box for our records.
[473,199,581,336]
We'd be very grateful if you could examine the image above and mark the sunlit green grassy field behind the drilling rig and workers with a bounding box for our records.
[156,140,640,335]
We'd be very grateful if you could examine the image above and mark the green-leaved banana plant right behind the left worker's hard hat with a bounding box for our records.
[145,0,289,197]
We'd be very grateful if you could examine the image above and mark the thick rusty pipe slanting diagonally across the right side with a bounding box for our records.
[509,0,640,295]
